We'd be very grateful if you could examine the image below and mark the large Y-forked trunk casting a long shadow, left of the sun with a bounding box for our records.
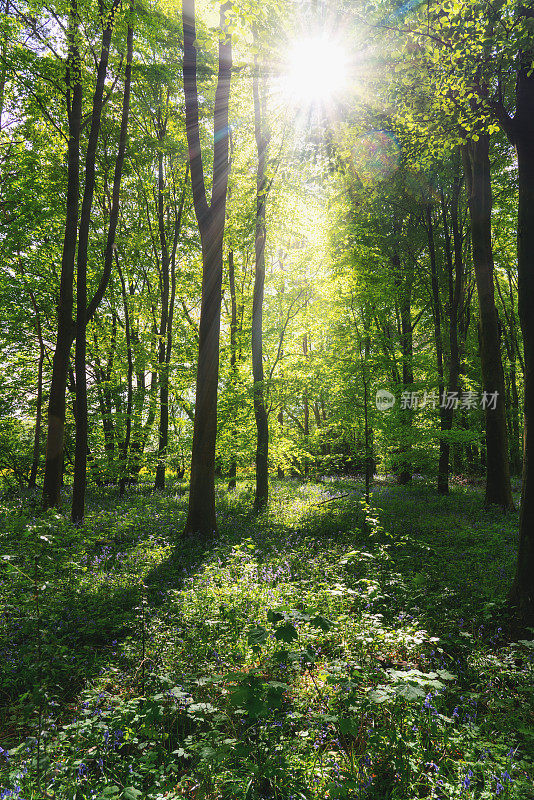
[182,0,232,539]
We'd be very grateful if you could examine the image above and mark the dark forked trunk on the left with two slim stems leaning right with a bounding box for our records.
[71,0,133,524]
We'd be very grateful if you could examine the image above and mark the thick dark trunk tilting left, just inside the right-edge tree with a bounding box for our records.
[462,134,514,509]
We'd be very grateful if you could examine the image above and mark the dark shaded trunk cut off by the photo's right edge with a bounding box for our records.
[510,53,534,625]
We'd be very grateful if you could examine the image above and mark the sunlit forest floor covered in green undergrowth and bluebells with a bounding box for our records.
[0,479,534,800]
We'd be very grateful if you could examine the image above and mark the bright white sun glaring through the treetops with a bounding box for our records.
[283,34,348,107]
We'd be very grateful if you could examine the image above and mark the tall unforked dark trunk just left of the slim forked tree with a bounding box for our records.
[43,0,82,509]
